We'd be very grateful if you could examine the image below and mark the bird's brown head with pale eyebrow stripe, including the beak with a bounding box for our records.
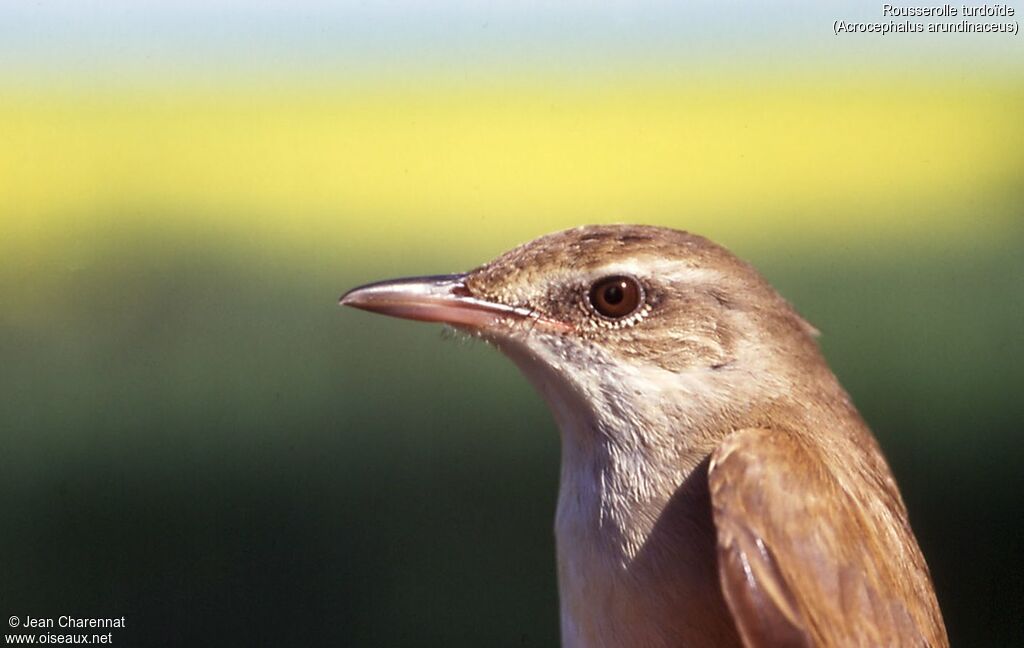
[341,225,817,440]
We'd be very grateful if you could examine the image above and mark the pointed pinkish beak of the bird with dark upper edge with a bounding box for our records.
[338,274,566,329]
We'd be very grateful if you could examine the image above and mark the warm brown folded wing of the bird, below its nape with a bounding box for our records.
[708,429,948,648]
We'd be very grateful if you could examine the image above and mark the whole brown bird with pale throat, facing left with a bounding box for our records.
[340,225,948,648]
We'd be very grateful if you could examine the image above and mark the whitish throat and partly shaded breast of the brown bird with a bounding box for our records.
[503,333,738,648]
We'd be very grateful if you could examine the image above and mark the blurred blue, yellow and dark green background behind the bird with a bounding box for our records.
[0,0,1024,646]
